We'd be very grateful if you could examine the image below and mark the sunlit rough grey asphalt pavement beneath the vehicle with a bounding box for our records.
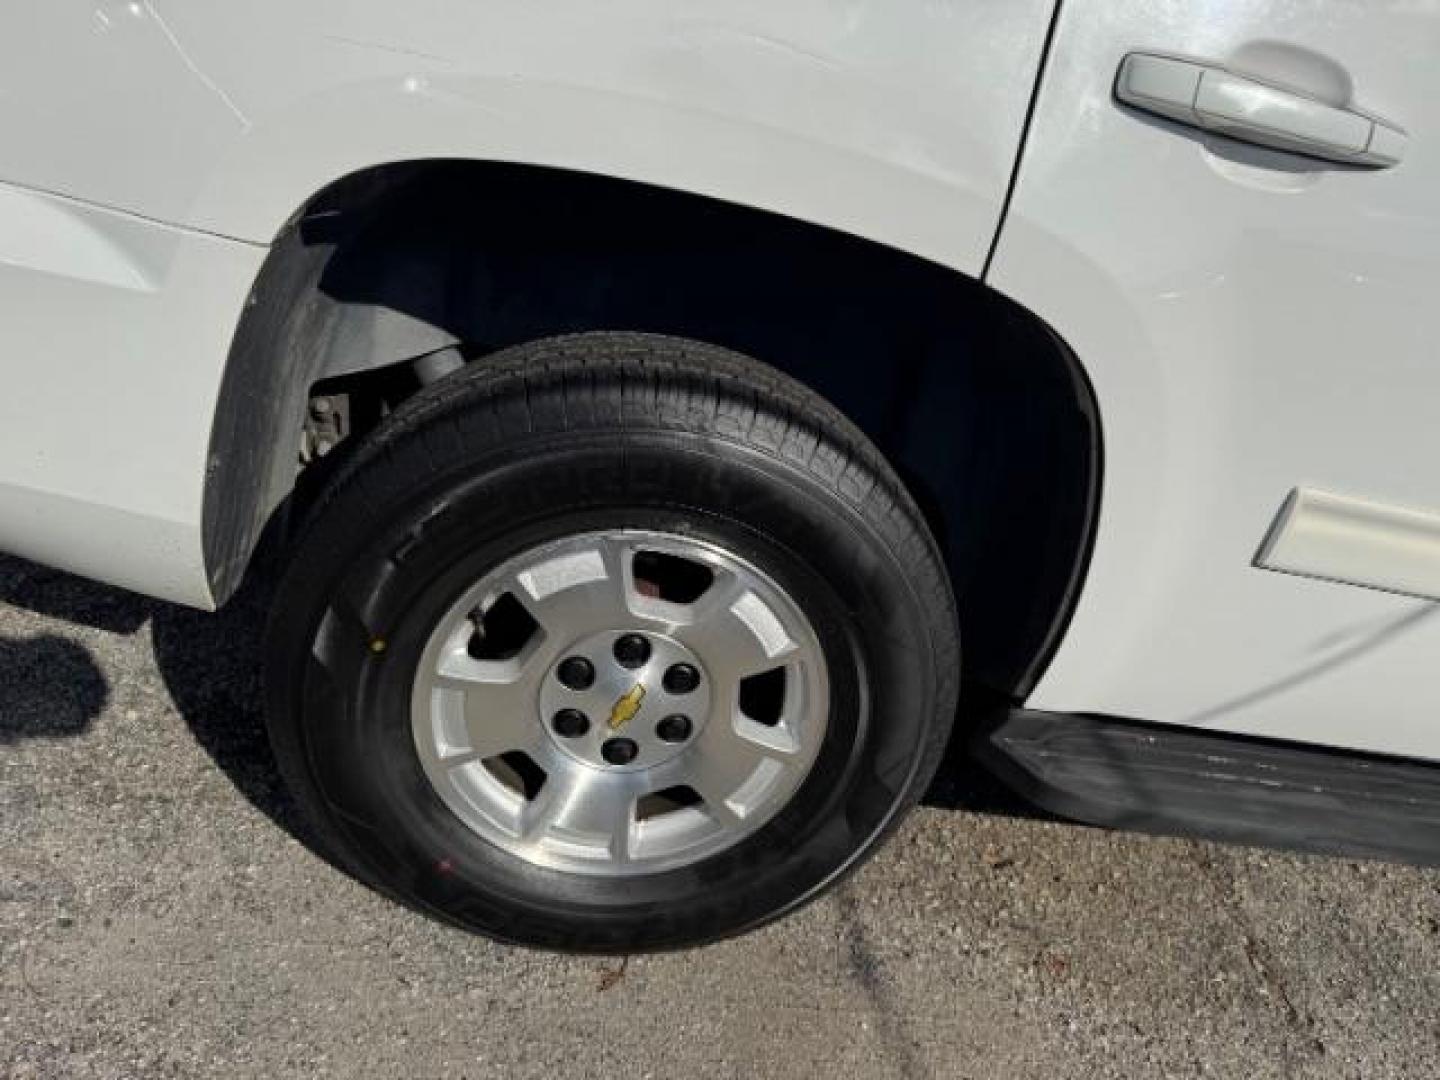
[0,559,1440,1080]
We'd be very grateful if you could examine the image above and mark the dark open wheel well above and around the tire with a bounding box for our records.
[204,161,1100,697]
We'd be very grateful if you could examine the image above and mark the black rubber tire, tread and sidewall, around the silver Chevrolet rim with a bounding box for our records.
[266,334,959,952]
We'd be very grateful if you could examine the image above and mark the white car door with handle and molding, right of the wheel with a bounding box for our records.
[989,0,1440,757]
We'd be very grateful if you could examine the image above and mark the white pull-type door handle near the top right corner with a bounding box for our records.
[1115,52,1407,168]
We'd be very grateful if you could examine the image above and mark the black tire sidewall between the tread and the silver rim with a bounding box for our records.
[269,431,943,949]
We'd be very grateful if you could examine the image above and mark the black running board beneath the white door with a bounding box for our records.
[973,708,1440,865]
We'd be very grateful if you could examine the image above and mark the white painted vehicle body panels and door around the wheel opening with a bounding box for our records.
[0,0,1440,759]
